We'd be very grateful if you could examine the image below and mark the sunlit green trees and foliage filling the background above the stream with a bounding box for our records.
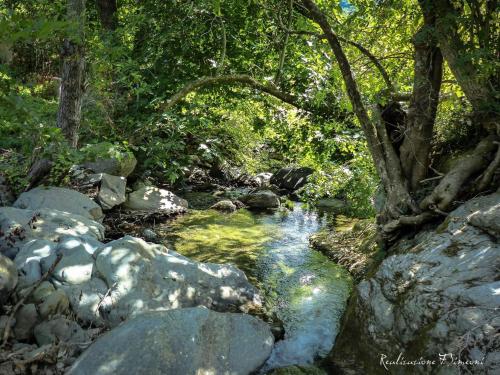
[0,0,500,232]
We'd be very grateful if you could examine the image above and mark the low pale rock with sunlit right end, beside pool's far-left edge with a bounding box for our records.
[124,186,188,214]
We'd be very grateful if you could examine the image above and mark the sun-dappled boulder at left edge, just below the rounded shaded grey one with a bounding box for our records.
[0,207,104,259]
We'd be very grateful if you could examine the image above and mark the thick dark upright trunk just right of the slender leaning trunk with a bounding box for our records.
[400,20,443,192]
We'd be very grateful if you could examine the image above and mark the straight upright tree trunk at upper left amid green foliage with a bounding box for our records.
[57,0,85,147]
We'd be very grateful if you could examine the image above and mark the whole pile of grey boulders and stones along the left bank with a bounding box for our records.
[0,155,273,374]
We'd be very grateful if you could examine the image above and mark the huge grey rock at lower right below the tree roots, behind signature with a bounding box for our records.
[332,193,500,374]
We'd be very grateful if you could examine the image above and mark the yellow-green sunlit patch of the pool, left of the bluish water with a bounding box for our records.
[162,210,279,282]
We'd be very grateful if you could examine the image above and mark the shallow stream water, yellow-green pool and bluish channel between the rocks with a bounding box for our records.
[160,204,352,371]
